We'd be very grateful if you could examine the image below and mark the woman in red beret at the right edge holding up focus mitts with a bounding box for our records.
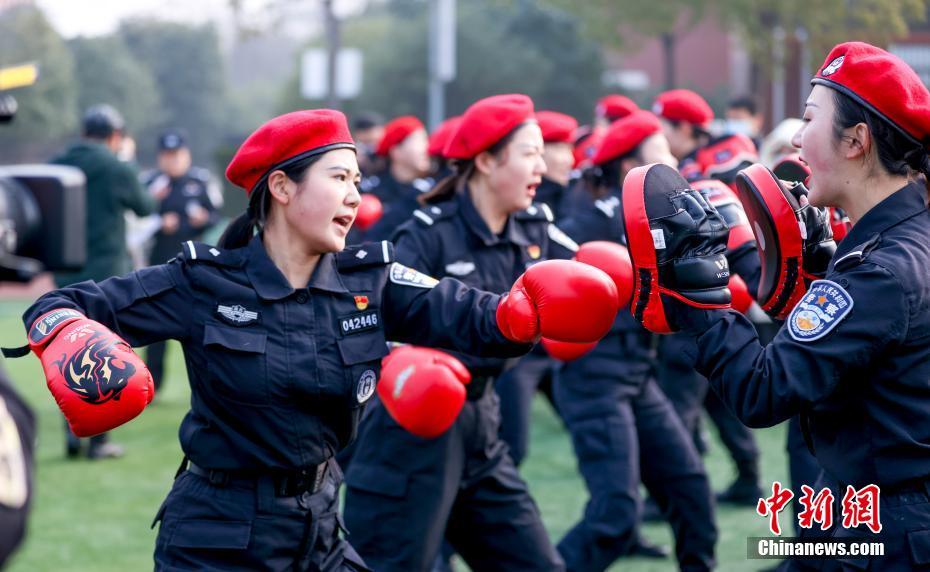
[647,42,930,570]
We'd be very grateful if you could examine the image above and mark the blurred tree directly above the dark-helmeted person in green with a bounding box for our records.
[68,36,162,142]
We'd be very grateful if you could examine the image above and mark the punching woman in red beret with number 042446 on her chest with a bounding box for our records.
[18,110,612,570]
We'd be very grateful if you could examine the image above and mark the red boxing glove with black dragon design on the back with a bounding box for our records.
[29,308,155,437]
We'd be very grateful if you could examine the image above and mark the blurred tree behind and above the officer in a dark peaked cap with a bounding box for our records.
[117,20,229,167]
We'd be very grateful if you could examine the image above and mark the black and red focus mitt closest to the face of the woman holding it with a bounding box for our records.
[736,164,836,320]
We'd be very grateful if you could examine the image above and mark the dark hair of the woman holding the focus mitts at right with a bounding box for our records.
[833,90,930,196]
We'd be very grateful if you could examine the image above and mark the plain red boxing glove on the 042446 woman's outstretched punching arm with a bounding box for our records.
[497,260,619,343]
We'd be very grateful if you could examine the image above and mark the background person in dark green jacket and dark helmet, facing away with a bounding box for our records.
[51,104,155,459]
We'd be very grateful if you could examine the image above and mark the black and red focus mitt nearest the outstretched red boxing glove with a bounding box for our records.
[623,163,730,334]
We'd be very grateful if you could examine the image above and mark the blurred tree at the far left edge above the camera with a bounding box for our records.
[0,5,78,156]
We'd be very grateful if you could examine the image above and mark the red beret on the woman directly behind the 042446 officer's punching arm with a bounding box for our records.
[443,94,533,159]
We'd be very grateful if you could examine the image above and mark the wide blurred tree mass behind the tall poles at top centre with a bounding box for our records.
[281,0,603,121]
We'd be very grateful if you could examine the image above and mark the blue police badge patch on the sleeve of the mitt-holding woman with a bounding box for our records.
[788,280,853,342]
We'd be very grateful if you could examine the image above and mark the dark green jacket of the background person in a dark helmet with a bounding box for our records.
[51,140,156,286]
